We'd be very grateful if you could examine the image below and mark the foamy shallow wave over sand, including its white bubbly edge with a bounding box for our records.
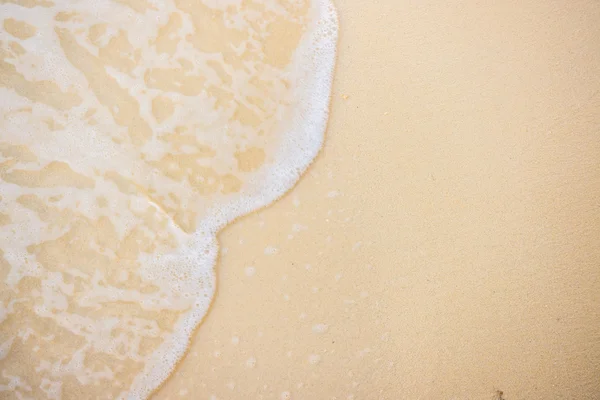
[0,0,337,399]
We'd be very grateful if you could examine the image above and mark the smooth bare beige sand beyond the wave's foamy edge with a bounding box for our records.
[154,0,600,400]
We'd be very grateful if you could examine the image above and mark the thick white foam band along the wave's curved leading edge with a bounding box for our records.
[127,0,338,400]
